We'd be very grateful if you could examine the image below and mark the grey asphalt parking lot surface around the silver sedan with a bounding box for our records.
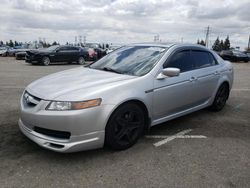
[0,57,250,188]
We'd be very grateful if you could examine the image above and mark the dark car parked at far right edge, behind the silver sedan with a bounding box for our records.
[220,50,249,62]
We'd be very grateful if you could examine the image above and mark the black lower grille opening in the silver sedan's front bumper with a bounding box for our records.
[34,126,71,139]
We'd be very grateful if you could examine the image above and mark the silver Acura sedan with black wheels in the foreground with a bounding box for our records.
[19,43,233,152]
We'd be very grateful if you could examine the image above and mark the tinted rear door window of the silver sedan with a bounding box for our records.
[191,51,213,68]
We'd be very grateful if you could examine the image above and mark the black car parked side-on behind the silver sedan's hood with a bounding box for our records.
[25,45,88,65]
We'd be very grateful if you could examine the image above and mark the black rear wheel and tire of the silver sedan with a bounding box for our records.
[210,83,229,112]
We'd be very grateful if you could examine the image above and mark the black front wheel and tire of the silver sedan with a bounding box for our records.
[105,103,146,150]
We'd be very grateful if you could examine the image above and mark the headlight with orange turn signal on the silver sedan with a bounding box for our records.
[46,98,102,111]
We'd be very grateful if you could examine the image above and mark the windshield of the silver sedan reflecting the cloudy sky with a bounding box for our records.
[90,46,167,76]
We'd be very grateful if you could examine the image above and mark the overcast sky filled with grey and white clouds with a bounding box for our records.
[0,0,250,49]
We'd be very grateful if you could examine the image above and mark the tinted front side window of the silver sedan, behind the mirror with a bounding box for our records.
[164,50,194,72]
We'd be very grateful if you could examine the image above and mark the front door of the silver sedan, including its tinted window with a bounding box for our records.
[153,50,197,119]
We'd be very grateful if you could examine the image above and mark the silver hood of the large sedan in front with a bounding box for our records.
[26,67,136,100]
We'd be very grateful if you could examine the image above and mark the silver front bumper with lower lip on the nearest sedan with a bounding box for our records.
[18,92,113,153]
